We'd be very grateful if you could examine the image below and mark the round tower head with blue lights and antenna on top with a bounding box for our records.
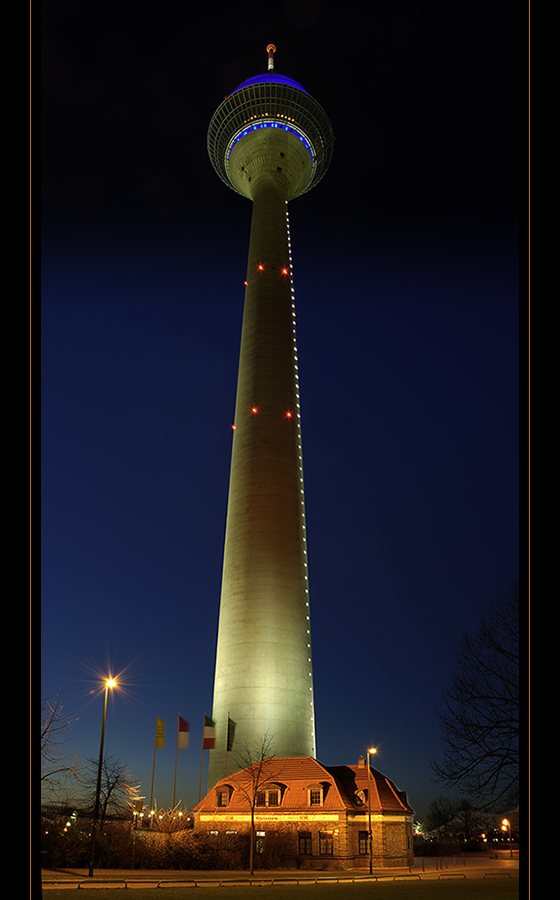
[207,44,334,199]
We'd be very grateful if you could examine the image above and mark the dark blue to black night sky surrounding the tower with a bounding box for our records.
[39,0,525,818]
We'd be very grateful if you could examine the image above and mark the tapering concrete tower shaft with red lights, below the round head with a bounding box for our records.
[208,176,315,786]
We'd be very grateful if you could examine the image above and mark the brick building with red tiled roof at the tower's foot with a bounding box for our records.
[194,756,413,868]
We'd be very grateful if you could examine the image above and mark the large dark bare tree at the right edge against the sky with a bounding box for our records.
[432,582,519,809]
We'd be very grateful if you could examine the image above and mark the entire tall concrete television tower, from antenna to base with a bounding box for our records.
[208,44,334,788]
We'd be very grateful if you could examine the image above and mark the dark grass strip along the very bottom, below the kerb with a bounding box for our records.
[43,876,519,900]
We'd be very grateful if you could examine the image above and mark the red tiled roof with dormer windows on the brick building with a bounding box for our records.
[194,756,412,813]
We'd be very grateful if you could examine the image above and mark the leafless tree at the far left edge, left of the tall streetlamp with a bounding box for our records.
[41,693,79,791]
